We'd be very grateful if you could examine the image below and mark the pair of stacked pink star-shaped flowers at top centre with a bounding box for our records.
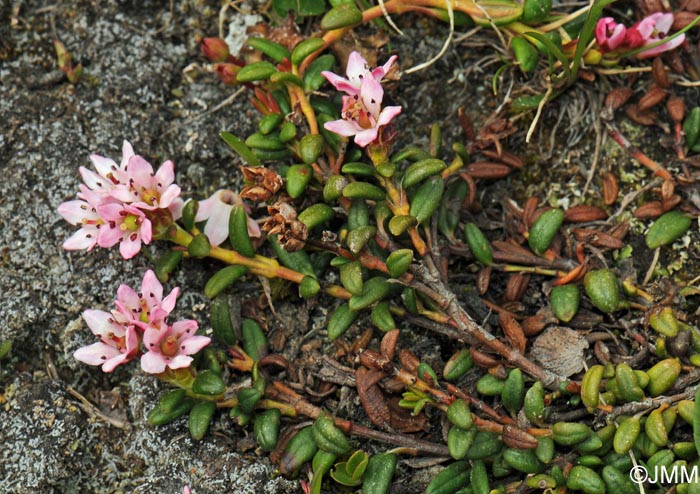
[321,51,401,147]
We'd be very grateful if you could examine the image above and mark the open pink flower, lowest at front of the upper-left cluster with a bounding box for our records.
[97,203,152,259]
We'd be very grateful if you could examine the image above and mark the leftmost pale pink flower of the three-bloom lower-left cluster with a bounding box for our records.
[73,310,139,372]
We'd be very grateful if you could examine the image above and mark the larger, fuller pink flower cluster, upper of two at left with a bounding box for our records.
[58,141,183,259]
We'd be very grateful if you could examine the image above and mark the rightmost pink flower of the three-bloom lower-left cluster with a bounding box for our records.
[141,319,211,374]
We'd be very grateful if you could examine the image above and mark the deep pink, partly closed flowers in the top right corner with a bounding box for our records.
[595,12,685,58]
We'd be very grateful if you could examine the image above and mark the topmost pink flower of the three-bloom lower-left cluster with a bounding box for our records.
[114,269,180,331]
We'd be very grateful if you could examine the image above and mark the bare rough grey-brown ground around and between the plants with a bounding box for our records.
[0,0,700,494]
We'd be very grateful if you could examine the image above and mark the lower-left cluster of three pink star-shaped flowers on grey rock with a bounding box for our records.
[73,270,211,374]
